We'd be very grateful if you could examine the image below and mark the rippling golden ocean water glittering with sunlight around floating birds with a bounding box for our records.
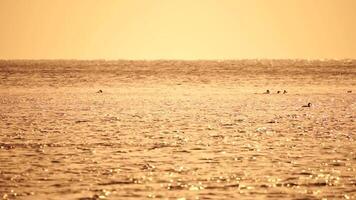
[0,60,356,200]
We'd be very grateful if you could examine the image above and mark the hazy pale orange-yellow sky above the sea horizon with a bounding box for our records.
[0,0,356,60]
